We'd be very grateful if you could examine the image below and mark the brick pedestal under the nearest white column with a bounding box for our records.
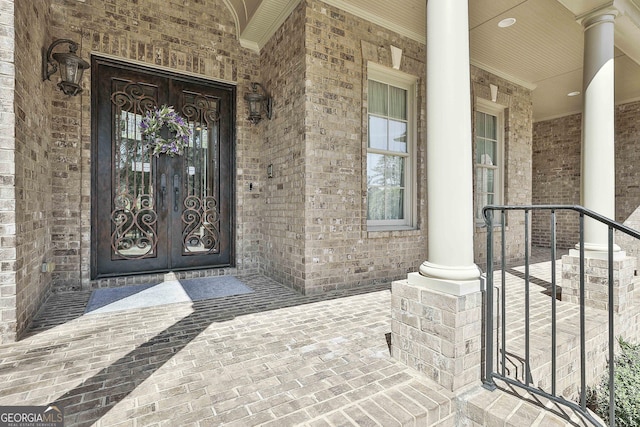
[391,280,482,391]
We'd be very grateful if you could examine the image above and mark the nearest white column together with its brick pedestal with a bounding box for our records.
[391,0,482,392]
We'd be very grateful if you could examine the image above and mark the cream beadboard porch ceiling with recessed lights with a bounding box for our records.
[234,0,640,121]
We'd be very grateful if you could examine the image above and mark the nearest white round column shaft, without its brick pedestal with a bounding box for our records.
[408,0,480,295]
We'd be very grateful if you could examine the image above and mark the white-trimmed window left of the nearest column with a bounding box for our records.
[367,63,417,230]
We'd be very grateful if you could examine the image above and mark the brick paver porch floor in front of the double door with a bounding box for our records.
[0,256,596,427]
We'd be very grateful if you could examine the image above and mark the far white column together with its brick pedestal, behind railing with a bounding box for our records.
[562,9,637,313]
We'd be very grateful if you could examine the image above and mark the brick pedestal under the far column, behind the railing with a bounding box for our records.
[562,250,637,313]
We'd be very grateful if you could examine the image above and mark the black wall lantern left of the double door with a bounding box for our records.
[42,39,89,96]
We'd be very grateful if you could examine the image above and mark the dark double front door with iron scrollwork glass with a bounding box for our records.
[91,57,235,278]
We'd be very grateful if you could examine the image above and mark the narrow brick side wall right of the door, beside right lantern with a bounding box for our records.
[260,2,306,291]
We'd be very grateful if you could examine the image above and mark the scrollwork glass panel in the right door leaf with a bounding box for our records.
[180,93,220,255]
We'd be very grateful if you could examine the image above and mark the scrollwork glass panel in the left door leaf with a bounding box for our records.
[111,81,158,260]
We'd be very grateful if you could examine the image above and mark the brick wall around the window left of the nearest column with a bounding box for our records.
[303,1,426,293]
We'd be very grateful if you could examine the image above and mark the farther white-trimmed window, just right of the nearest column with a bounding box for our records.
[474,99,504,224]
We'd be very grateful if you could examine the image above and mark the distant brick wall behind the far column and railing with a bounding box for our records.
[532,102,640,256]
